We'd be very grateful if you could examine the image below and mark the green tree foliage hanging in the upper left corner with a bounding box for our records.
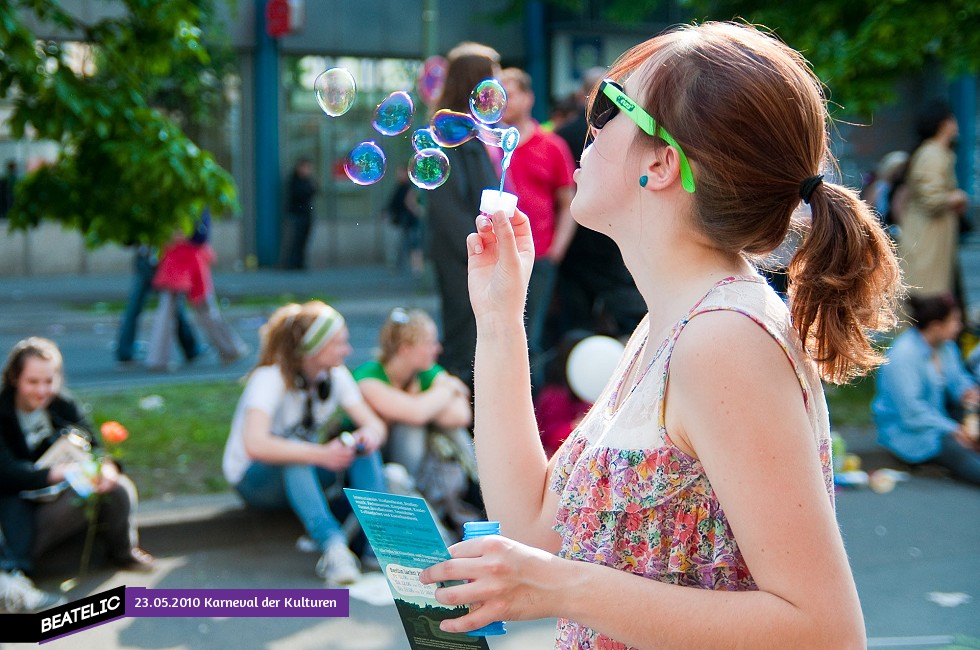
[0,0,238,245]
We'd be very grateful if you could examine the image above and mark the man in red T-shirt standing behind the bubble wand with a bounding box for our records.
[500,68,576,389]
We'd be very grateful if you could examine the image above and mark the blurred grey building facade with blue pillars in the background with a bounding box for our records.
[0,0,980,276]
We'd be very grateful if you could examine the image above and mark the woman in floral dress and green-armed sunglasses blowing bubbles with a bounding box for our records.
[420,22,902,649]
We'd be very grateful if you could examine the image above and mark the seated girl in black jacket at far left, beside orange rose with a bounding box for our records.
[0,337,153,575]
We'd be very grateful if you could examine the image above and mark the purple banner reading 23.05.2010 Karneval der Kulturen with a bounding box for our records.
[126,587,350,618]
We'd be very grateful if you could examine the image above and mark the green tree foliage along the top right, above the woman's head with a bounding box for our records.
[514,0,980,115]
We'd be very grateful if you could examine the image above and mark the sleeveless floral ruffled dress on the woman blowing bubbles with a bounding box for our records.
[550,276,834,650]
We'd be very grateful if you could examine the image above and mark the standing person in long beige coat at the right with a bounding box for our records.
[898,100,967,298]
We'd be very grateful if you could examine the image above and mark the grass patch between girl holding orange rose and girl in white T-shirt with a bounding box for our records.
[75,381,242,499]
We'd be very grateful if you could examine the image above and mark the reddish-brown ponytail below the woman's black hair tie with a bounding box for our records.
[789,182,902,384]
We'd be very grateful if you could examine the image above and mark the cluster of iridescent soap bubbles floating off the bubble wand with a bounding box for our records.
[313,68,520,190]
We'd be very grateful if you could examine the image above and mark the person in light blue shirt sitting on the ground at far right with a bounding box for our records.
[871,293,980,485]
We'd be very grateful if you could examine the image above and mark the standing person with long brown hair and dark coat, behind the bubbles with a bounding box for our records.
[427,42,500,385]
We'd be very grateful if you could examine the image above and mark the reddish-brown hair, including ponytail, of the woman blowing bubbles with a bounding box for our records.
[610,23,901,383]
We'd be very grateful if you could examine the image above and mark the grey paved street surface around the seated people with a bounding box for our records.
[0,247,980,650]
